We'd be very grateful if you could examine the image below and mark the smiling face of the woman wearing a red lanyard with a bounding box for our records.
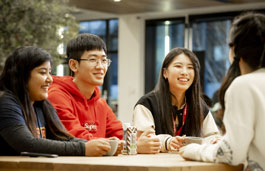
[163,53,195,94]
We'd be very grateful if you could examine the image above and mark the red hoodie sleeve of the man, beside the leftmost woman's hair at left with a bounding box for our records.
[49,89,96,140]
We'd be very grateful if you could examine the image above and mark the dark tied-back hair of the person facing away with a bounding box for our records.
[219,12,265,110]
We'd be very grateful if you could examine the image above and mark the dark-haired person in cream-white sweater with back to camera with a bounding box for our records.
[181,13,265,171]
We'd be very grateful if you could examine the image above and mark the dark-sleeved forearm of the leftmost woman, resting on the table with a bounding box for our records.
[0,125,85,156]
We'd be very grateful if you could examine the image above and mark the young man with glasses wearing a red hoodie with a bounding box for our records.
[49,34,123,152]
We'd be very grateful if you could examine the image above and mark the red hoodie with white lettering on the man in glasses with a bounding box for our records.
[49,76,123,140]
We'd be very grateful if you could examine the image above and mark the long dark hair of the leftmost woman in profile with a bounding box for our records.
[0,46,73,140]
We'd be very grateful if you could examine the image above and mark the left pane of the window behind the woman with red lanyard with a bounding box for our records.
[145,18,185,93]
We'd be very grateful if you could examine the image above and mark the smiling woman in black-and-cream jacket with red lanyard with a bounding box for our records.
[133,48,219,153]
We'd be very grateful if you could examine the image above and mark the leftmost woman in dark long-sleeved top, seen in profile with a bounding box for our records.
[0,46,110,156]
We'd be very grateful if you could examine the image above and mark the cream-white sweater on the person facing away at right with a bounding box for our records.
[181,69,265,170]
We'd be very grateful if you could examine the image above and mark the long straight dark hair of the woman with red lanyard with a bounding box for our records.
[154,47,203,136]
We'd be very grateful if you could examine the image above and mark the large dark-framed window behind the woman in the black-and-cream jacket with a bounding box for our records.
[145,10,264,101]
